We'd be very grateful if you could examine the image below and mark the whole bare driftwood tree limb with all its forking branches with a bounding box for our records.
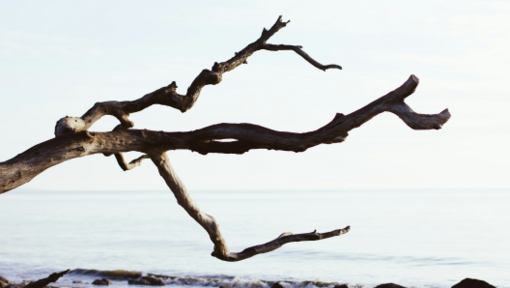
[0,17,450,262]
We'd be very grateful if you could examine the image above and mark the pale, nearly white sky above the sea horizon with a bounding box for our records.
[0,0,510,190]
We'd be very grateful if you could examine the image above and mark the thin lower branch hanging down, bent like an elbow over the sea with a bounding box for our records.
[150,152,350,262]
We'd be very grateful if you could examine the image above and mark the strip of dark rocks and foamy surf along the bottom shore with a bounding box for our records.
[0,269,502,288]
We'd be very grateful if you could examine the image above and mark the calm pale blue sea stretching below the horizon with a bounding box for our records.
[0,189,510,288]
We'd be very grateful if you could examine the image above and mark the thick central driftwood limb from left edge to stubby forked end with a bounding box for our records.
[0,75,450,193]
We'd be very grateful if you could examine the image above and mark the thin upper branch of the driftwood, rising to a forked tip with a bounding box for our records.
[55,16,342,137]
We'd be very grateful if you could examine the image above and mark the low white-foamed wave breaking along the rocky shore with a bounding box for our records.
[68,269,344,288]
